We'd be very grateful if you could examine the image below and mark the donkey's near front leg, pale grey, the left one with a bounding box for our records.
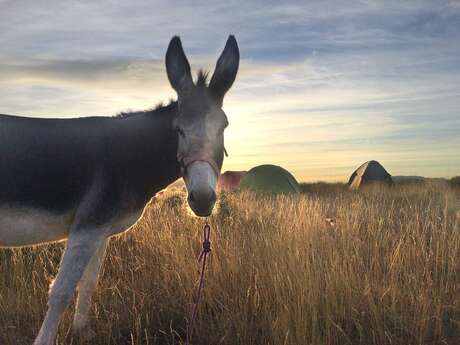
[34,229,105,345]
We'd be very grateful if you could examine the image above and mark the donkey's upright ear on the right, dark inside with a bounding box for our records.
[209,35,240,103]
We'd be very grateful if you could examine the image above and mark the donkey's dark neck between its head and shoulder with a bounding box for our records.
[108,102,180,202]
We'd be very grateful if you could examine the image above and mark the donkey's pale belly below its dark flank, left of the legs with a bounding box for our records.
[0,207,74,247]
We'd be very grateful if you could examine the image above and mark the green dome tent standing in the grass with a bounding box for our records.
[239,164,300,194]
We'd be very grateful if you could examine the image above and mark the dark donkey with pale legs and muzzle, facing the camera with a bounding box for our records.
[0,35,239,345]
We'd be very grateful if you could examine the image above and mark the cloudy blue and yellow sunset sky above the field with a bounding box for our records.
[0,0,460,181]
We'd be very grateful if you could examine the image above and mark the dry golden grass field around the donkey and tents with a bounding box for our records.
[0,183,460,345]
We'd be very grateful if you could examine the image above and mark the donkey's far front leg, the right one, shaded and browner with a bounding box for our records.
[72,238,108,340]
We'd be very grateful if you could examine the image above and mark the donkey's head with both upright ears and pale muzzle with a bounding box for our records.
[166,36,240,217]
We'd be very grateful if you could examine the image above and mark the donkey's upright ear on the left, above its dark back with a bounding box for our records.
[166,36,193,96]
